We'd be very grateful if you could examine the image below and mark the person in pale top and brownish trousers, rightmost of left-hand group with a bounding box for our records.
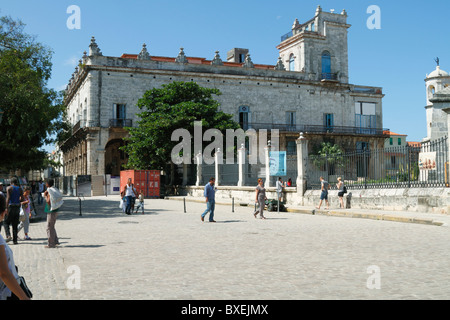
[44,179,64,248]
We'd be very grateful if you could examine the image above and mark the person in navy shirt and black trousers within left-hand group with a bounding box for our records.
[3,177,23,244]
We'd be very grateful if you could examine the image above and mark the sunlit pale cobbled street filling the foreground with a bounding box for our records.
[5,196,450,300]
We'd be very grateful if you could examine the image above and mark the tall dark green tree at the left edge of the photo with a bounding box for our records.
[0,17,63,170]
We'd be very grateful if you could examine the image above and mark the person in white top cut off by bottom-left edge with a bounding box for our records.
[0,196,30,300]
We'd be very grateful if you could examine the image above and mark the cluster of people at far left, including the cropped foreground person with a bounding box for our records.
[0,177,64,300]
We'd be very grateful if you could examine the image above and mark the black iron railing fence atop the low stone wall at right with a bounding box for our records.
[307,137,449,190]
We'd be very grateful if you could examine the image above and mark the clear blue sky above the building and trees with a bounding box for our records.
[0,0,450,151]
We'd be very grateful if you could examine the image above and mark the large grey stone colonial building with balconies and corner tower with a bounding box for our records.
[61,7,385,175]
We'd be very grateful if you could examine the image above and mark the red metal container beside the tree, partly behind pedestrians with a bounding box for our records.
[120,170,161,198]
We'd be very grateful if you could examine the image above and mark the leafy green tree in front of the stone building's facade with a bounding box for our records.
[122,82,239,170]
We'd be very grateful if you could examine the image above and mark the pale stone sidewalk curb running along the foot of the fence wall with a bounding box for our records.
[164,196,445,227]
